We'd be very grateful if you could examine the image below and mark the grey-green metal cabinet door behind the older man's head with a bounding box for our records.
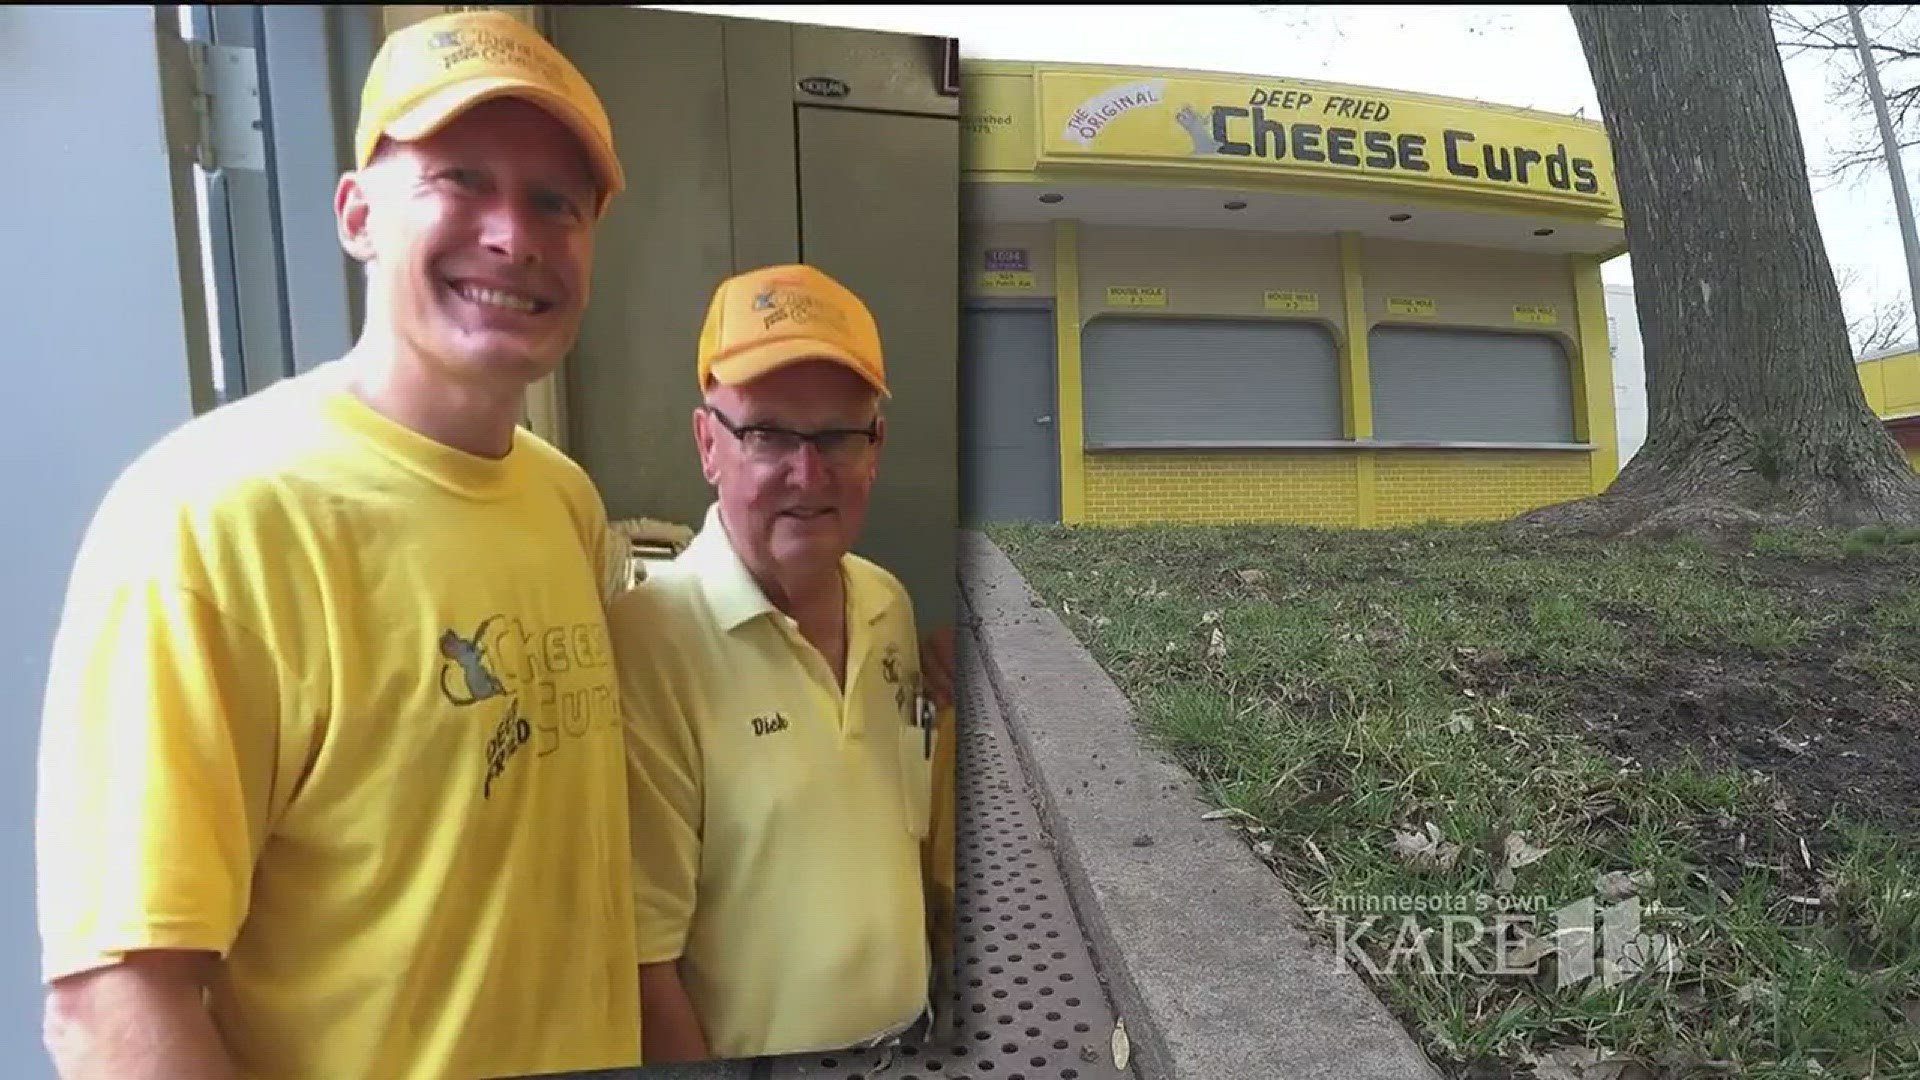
[795,106,960,628]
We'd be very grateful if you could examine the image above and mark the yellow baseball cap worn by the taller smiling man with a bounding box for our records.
[353,12,626,213]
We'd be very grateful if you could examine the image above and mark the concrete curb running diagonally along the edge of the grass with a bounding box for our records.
[960,532,1440,1080]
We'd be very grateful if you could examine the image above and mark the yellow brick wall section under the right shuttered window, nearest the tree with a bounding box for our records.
[1373,450,1594,525]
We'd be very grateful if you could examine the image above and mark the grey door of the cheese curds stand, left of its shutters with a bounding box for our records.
[960,307,1060,525]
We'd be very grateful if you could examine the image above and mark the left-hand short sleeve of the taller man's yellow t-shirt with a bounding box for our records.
[36,521,284,980]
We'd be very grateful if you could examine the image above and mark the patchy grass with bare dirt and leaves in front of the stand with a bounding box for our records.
[993,527,1920,1076]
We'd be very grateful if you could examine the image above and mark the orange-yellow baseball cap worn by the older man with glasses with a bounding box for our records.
[699,263,891,396]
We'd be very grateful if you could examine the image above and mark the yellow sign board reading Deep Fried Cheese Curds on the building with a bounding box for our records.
[1039,71,1619,213]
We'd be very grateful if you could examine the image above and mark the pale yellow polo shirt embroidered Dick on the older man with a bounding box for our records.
[609,509,933,1057]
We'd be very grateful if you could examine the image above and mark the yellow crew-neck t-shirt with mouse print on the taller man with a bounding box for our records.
[38,363,639,1080]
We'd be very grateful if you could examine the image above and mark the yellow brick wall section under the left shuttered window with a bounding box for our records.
[1087,450,1359,525]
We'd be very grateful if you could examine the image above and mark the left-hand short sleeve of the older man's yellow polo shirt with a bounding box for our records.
[609,582,705,965]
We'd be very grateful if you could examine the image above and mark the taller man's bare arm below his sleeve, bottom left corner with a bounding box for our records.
[44,949,240,1080]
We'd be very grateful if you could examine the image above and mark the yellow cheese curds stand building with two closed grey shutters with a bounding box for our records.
[960,61,1626,527]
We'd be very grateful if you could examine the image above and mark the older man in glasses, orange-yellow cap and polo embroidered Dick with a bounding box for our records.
[611,265,933,1061]
